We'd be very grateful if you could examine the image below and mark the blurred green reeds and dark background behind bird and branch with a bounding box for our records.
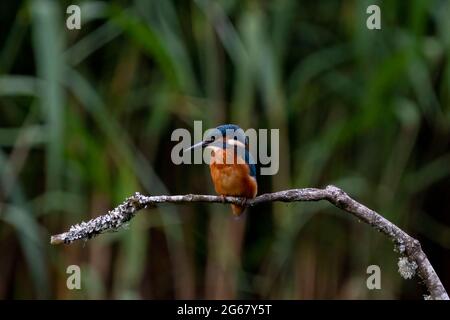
[0,0,450,299]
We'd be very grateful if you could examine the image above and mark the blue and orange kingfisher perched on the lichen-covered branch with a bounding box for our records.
[185,124,258,217]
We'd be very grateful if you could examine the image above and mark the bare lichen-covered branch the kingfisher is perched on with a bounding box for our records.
[50,186,449,300]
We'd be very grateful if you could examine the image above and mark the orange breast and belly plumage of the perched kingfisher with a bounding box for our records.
[210,149,258,198]
